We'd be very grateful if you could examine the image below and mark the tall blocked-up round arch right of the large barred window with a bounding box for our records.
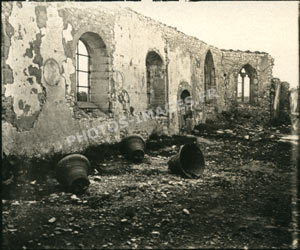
[146,51,166,111]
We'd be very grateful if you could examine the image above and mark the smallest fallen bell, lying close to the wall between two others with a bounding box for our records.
[120,135,145,162]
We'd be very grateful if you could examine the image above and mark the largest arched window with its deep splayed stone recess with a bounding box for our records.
[76,32,109,112]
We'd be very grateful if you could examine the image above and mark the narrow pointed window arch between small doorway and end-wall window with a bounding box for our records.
[204,50,216,102]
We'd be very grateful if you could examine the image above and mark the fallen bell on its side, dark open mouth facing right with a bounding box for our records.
[168,143,205,178]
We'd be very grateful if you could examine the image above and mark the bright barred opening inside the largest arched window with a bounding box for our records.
[76,40,91,102]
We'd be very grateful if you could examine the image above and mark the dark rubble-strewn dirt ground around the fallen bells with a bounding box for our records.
[2,114,295,249]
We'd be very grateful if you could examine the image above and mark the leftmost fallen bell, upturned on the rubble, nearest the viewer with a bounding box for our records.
[55,154,90,194]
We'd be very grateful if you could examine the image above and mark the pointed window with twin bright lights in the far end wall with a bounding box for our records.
[236,64,258,103]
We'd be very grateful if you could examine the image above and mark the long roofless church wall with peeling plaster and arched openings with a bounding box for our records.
[1,2,274,157]
